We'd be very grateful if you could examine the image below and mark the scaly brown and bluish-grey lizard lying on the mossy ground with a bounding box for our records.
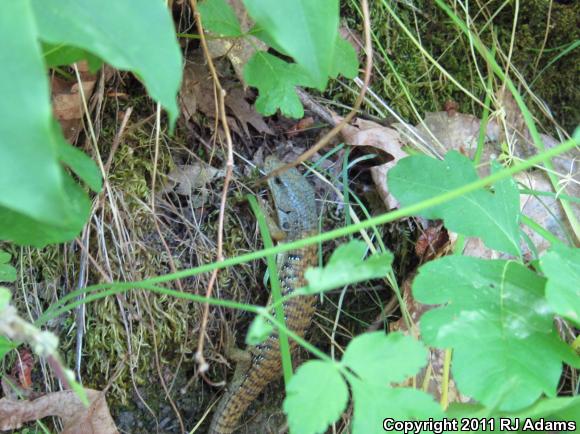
[209,157,318,434]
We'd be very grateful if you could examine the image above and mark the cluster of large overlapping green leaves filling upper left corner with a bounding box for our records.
[0,0,181,246]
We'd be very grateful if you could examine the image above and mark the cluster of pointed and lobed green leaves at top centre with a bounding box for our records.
[199,0,358,118]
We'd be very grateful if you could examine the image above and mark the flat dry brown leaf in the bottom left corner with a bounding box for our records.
[0,389,119,434]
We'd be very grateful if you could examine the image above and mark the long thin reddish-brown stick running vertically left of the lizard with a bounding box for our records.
[190,0,234,374]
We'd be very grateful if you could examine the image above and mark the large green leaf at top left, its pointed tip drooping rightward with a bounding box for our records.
[31,0,182,124]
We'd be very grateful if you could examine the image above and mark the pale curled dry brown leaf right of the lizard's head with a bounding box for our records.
[335,117,407,209]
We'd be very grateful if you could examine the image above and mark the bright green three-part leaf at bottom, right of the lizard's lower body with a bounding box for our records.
[284,332,442,434]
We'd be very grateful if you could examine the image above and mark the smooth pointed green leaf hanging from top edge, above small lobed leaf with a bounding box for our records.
[244,0,339,90]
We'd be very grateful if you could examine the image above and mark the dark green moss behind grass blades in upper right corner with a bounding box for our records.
[340,0,580,132]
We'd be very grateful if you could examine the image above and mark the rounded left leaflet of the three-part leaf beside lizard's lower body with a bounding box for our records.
[283,360,348,434]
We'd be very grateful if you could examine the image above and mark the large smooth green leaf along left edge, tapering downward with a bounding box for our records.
[0,1,70,226]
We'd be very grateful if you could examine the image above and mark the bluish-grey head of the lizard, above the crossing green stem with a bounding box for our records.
[264,156,318,237]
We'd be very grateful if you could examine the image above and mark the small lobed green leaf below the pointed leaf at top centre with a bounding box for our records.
[244,51,310,118]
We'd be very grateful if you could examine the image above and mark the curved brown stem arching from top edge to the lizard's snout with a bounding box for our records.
[266,0,373,179]
